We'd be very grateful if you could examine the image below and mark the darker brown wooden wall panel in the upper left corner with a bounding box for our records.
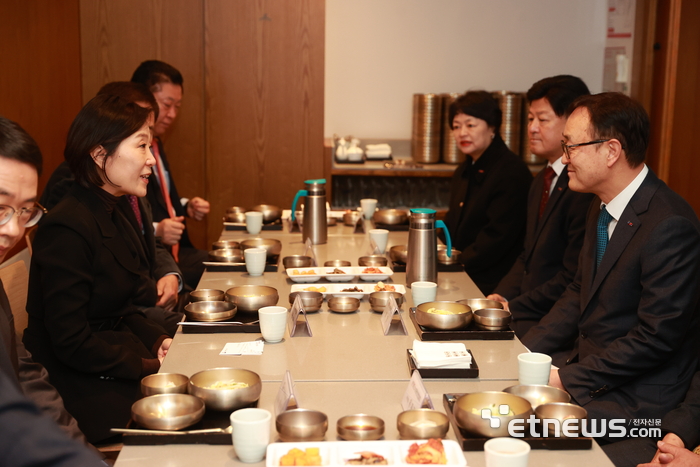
[0,0,81,195]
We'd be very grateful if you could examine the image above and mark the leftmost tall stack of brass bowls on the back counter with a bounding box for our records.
[411,94,442,164]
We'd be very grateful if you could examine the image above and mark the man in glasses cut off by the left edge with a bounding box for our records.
[0,117,97,458]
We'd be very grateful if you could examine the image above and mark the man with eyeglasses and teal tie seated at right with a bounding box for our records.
[522,93,700,458]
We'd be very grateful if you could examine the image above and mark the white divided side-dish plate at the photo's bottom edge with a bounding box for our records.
[265,439,467,467]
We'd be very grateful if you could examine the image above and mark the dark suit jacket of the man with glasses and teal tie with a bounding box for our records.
[523,171,700,428]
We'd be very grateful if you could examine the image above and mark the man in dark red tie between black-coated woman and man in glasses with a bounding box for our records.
[486,75,593,338]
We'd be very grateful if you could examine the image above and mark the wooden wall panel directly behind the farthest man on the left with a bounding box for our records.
[80,0,209,248]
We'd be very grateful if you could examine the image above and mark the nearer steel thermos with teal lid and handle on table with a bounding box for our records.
[406,209,452,287]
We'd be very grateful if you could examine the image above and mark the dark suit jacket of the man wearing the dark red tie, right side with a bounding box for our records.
[496,168,594,337]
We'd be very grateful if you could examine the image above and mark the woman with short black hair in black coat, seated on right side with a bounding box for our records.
[445,91,532,295]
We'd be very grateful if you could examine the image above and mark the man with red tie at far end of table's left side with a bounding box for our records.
[131,60,209,289]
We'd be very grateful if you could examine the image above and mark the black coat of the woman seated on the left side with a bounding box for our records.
[24,185,166,442]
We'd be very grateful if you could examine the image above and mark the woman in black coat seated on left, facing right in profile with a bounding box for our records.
[24,95,172,443]
